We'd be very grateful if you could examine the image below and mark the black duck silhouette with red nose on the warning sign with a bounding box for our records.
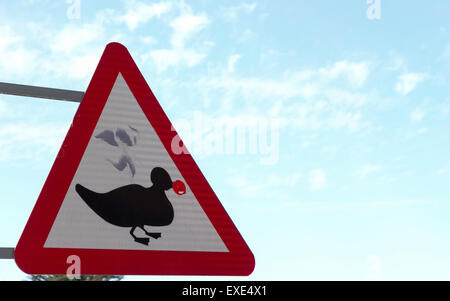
[75,167,186,245]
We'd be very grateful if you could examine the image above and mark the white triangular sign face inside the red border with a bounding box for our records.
[44,73,228,252]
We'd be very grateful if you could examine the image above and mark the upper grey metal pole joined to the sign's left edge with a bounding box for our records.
[0,82,84,102]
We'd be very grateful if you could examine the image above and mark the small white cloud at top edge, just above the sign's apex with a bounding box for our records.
[117,1,173,31]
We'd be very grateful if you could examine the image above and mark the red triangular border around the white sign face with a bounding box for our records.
[15,43,255,276]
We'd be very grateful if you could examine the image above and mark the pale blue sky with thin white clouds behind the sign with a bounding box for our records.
[0,0,450,280]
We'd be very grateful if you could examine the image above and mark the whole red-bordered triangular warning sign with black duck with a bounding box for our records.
[15,43,254,275]
